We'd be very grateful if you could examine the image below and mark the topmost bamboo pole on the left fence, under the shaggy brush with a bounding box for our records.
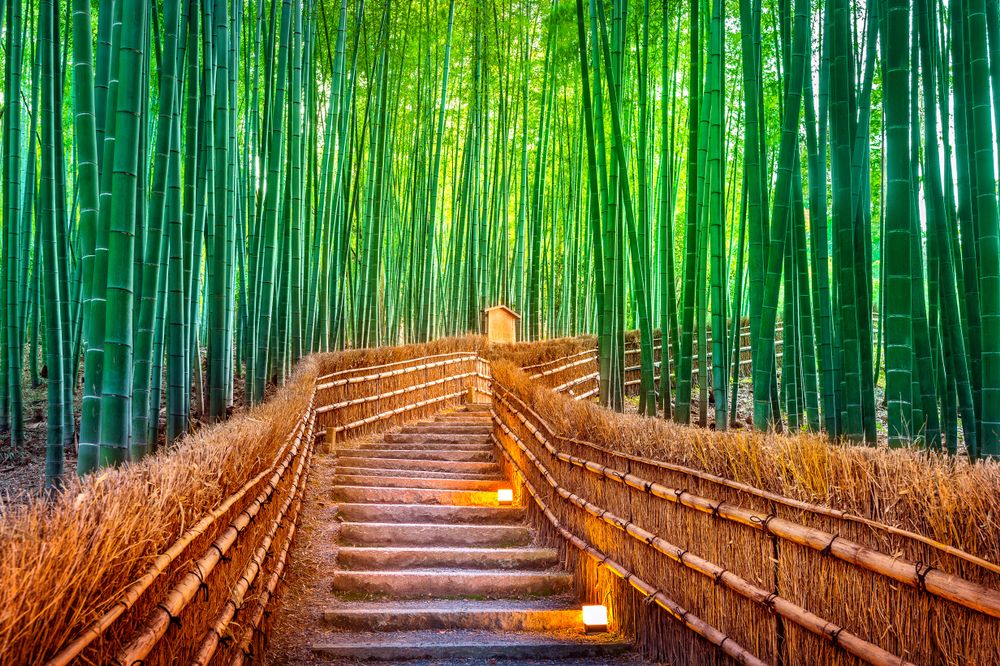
[46,391,316,666]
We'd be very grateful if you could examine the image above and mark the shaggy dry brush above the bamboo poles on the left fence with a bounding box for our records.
[0,359,320,664]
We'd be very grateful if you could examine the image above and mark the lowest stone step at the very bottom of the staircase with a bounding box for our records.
[312,629,631,665]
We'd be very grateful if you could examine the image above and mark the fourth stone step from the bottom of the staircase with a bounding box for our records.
[337,546,559,571]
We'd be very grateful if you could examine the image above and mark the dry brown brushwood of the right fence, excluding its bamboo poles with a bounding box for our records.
[493,362,1000,664]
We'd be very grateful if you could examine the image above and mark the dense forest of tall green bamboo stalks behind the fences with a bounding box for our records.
[0,0,1000,489]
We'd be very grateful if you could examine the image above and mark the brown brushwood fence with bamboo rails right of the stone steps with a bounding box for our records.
[493,363,1000,664]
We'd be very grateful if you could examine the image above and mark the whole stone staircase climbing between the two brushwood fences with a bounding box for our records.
[312,405,634,664]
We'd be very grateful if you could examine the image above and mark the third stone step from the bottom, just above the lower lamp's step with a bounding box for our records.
[333,569,573,599]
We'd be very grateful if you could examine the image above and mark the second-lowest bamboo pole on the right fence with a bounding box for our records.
[494,421,913,666]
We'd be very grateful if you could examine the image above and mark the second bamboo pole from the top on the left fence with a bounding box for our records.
[116,404,305,666]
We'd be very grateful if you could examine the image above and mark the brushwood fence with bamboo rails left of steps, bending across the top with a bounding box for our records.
[0,337,489,665]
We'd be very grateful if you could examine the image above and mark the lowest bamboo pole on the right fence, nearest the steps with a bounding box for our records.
[500,438,767,666]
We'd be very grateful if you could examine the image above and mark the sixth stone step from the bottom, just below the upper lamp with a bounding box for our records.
[338,504,524,525]
